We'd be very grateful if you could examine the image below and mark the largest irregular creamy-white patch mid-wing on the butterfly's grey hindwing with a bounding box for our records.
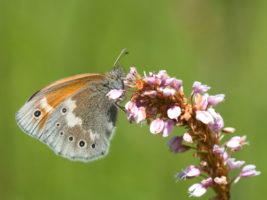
[63,98,82,127]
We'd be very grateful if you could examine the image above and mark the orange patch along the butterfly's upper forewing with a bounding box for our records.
[38,74,104,129]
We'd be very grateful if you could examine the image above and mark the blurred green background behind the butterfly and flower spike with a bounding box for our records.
[0,0,267,200]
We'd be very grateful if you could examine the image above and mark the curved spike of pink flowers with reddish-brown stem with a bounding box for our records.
[107,67,260,199]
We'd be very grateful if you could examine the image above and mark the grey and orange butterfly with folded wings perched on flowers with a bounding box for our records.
[16,49,127,162]
